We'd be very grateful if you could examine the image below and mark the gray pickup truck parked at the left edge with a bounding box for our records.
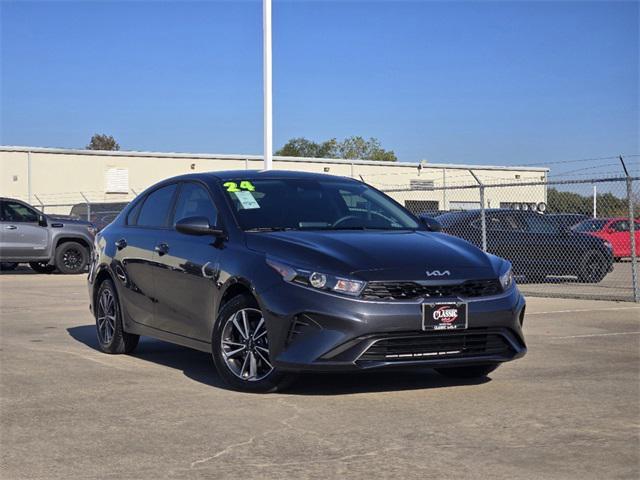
[0,198,96,273]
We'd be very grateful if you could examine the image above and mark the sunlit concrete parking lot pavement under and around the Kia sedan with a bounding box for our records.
[0,272,640,479]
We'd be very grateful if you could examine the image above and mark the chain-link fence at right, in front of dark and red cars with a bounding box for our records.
[386,176,640,301]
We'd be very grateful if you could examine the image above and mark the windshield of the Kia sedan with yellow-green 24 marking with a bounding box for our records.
[223,176,421,231]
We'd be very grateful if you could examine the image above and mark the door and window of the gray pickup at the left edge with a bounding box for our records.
[0,200,49,262]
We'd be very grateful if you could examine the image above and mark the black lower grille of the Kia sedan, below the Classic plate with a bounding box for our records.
[358,330,516,362]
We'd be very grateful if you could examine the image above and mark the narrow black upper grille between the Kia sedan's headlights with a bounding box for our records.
[362,279,502,300]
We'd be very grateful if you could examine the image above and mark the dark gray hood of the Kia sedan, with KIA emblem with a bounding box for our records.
[247,231,498,281]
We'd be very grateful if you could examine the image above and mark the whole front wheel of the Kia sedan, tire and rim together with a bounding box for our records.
[211,294,290,393]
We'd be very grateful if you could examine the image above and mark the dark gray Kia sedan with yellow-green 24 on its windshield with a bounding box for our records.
[88,171,526,392]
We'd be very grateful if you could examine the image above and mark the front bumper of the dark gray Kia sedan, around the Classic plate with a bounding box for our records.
[258,283,526,371]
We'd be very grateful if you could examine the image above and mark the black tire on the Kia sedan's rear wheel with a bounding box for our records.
[93,280,140,353]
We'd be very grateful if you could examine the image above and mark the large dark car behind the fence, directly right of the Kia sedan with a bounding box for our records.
[436,209,613,283]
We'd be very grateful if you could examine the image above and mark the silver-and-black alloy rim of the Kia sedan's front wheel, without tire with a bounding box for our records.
[220,308,273,382]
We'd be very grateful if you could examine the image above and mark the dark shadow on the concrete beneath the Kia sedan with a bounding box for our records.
[67,324,491,395]
